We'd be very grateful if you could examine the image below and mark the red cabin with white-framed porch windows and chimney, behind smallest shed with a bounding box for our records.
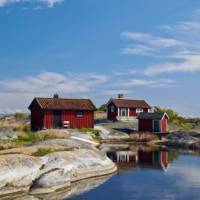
[107,94,151,120]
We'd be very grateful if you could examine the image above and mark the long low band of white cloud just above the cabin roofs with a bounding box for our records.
[0,69,175,114]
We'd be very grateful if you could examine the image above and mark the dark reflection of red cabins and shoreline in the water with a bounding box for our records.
[103,145,177,173]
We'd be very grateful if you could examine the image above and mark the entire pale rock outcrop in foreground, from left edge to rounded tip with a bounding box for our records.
[0,149,116,199]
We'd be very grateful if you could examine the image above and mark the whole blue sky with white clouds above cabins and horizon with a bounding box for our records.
[0,0,200,117]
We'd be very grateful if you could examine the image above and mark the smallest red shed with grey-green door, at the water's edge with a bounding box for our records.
[138,112,169,133]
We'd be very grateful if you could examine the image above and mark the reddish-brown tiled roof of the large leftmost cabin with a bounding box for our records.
[29,97,96,111]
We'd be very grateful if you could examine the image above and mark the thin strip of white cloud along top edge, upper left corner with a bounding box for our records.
[0,0,64,8]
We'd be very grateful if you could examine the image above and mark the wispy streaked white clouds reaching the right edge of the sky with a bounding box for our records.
[122,10,200,76]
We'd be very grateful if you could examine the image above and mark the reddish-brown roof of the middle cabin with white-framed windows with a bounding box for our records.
[108,99,151,109]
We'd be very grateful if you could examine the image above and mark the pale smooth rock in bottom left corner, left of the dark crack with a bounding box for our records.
[0,155,43,196]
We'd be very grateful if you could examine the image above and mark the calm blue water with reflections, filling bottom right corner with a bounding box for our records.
[72,146,200,200]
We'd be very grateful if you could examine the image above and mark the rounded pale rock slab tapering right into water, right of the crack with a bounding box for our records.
[32,149,116,193]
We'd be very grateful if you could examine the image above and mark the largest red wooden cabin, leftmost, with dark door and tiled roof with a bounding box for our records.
[29,95,96,131]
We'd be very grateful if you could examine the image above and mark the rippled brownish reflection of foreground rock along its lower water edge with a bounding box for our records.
[32,176,110,200]
